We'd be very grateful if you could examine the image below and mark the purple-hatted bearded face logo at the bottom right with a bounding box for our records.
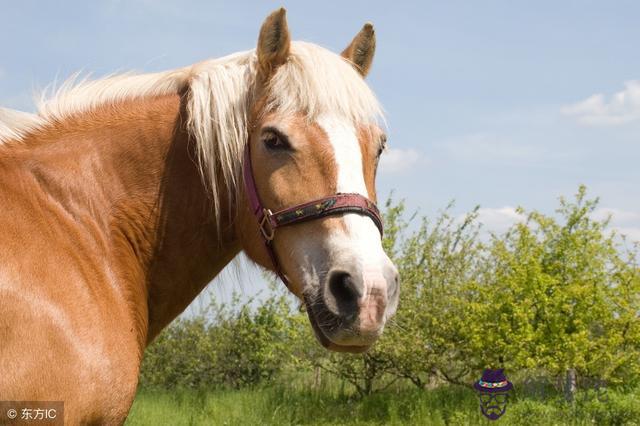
[473,368,513,420]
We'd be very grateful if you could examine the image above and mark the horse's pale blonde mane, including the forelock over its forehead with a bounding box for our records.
[0,42,382,225]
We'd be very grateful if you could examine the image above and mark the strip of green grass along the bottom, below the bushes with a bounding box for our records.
[126,385,640,426]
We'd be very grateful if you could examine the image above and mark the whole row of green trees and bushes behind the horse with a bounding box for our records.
[141,187,640,395]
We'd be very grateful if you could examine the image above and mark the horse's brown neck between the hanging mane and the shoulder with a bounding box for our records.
[18,95,239,345]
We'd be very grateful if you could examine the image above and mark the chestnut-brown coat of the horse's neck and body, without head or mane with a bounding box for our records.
[0,96,240,423]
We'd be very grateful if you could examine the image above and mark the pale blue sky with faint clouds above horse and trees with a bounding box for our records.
[0,0,640,304]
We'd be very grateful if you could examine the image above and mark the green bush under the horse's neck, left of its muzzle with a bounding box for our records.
[140,291,305,388]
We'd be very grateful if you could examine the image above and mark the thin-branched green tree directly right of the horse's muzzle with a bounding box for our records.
[382,204,480,387]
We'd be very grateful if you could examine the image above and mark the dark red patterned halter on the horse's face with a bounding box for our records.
[242,143,383,287]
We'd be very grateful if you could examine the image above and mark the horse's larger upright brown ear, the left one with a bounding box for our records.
[257,7,291,78]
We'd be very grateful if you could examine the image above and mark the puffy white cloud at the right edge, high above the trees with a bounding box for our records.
[561,80,640,126]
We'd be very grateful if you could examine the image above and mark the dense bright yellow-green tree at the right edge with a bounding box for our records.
[465,187,640,400]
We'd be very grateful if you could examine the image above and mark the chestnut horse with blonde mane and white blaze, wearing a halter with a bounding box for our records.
[0,9,399,424]
